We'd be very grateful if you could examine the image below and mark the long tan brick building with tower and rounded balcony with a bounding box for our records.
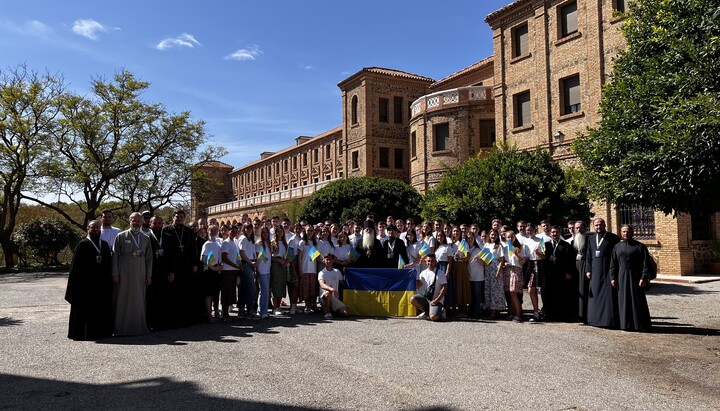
[193,0,720,275]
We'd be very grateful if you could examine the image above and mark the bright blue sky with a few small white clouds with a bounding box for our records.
[5,0,511,167]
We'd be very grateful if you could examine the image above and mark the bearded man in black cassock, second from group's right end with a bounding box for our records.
[585,218,620,328]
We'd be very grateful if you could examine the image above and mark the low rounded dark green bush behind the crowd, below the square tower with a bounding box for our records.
[299,177,421,223]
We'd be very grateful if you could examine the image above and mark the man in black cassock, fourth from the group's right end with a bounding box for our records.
[543,226,577,321]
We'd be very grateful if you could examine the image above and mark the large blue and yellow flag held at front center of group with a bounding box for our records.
[343,267,417,317]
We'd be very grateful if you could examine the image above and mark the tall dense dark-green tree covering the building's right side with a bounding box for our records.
[573,0,720,214]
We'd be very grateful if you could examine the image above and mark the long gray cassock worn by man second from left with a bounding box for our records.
[112,230,153,335]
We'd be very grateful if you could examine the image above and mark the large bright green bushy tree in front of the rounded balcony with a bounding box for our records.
[422,146,590,227]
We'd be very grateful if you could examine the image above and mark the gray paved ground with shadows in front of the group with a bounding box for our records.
[0,273,720,410]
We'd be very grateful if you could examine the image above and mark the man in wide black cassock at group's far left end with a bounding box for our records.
[65,221,113,340]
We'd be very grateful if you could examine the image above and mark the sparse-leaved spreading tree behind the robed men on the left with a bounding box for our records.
[25,70,217,229]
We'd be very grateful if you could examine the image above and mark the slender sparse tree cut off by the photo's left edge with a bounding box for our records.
[0,65,64,268]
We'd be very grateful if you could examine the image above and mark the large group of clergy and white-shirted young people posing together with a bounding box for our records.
[65,210,655,340]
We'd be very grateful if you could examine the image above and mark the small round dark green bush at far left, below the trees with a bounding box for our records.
[14,218,79,265]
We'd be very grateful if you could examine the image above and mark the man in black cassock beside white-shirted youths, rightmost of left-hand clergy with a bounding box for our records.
[162,210,200,327]
